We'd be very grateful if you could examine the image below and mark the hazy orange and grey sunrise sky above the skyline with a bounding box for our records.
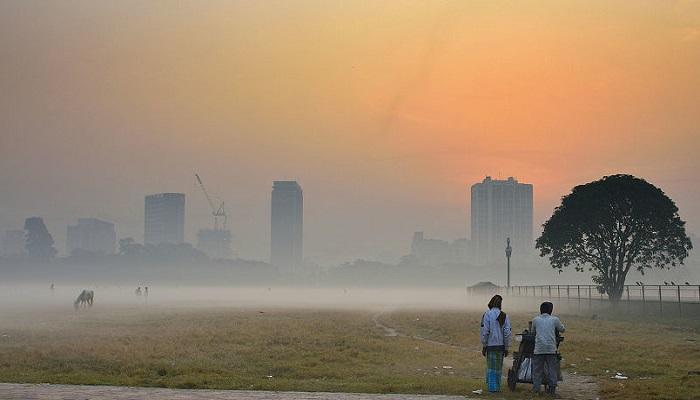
[0,0,700,264]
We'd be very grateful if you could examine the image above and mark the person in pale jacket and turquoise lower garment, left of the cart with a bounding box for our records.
[481,295,511,392]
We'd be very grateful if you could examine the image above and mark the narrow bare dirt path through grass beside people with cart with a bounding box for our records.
[372,312,600,400]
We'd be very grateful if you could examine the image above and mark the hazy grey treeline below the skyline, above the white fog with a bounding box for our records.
[0,250,700,287]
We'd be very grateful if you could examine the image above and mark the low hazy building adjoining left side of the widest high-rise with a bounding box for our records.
[411,232,469,266]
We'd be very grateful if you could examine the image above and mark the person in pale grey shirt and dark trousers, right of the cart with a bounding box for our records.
[532,301,565,395]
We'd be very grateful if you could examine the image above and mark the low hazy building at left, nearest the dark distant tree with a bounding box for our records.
[66,218,117,254]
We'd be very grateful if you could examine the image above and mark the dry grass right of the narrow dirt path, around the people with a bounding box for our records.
[384,312,700,399]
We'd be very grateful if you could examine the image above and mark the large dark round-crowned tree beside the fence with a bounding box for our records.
[535,175,693,302]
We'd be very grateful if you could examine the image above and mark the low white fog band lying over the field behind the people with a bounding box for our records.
[0,285,564,314]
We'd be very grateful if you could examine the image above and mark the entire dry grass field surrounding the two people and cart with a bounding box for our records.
[0,307,700,399]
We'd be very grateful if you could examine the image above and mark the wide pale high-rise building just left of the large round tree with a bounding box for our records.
[471,176,534,265]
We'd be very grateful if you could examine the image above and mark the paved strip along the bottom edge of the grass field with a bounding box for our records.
[0,383,465,400]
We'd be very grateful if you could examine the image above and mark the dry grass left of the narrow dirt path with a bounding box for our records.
[0,309,478,393]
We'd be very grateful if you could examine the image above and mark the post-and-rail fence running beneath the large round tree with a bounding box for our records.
[503,285,700,316]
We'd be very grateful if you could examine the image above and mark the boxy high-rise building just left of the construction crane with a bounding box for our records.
[143,193,185,245]
